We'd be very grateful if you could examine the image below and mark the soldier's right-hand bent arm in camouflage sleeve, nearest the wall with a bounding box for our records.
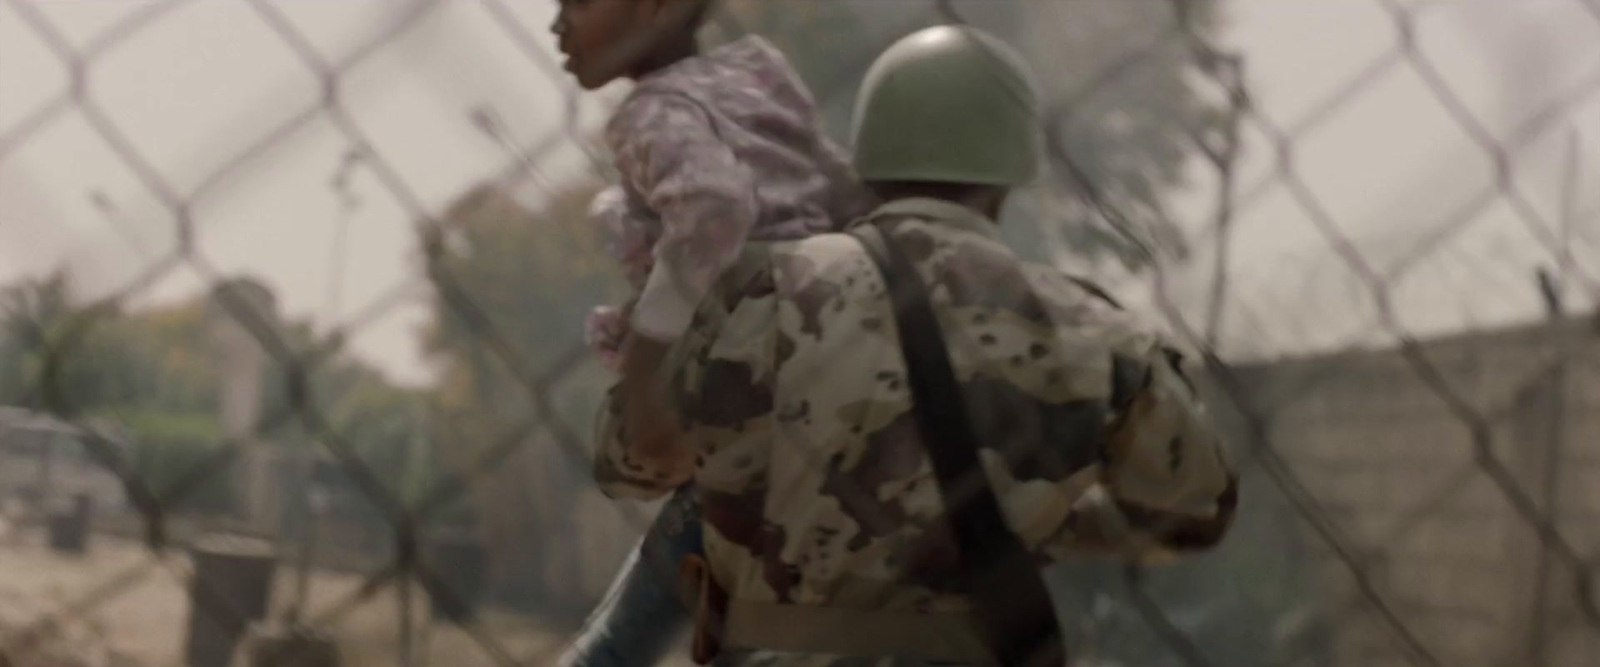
[1011,266,1238,561]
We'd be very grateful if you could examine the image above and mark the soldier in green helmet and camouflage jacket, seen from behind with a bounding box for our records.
[595,27,1237,665]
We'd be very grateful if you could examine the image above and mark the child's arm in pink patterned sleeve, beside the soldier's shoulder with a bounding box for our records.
[608,93,757,341]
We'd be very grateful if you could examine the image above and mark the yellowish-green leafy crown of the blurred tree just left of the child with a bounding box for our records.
[424,182,624,422]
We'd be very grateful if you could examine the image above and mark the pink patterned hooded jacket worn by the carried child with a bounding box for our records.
[605,37,874,341]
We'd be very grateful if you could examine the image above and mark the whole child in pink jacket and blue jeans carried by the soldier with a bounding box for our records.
[552,0,872,665]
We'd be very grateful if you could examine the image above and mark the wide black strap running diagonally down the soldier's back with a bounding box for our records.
[850,224,1066,667]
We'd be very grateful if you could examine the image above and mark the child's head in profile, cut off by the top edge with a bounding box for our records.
[550,0,714,90]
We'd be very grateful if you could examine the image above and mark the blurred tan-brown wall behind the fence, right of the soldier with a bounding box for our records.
[1213,313,1600,667]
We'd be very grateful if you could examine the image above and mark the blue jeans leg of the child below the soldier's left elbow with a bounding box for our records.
[560,486,702,667]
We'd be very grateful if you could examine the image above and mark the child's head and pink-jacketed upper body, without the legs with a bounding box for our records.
[552,0,867,358]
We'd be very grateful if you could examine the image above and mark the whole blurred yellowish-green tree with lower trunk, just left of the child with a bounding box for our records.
[422,181,624,606]
